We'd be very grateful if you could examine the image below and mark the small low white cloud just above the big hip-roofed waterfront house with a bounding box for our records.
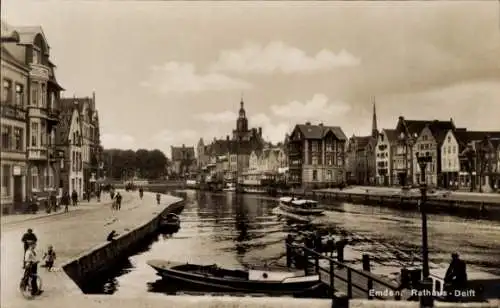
[271,94,351,123]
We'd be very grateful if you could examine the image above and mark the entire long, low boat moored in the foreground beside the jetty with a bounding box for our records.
[147,260,323,296]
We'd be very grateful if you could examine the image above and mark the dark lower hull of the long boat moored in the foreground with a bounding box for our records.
[148,261,323,296]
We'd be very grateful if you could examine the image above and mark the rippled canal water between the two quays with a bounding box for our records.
[83,190,500,296]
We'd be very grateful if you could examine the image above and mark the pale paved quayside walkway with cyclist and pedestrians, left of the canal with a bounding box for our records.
[0,192,181,308]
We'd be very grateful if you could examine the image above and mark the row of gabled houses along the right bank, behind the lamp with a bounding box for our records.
[346,104,500,191]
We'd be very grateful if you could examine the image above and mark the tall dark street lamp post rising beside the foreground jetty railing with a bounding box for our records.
[415,152,433,307]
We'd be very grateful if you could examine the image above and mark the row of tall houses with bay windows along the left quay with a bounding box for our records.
[0,21,101,213]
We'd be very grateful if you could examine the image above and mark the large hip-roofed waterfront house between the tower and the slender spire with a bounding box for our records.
[288,122,347,187]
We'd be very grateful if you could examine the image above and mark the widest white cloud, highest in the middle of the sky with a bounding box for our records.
[211,41,361,73]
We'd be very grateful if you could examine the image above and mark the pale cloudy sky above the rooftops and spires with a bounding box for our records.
[2,0,500,155]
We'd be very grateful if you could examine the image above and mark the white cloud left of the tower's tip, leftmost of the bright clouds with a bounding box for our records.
[141,62,252,93]
